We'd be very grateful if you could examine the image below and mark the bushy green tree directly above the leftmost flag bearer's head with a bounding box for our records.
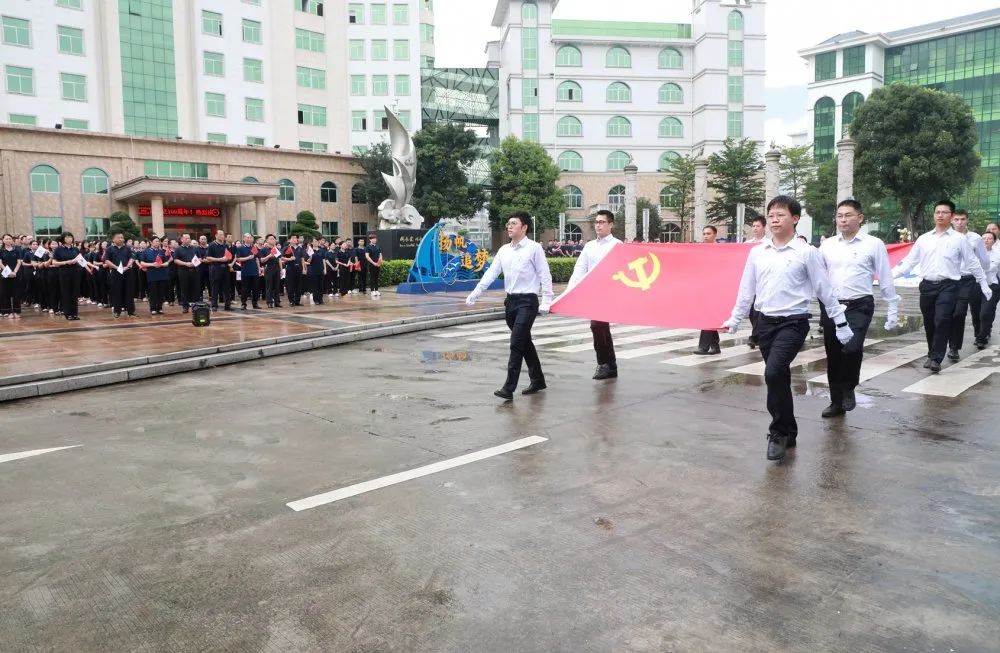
[490,136,566,232]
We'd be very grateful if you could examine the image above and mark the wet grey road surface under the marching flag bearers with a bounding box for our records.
[0,296,1000,653]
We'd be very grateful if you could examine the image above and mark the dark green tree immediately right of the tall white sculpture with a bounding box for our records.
[412,122,486,226]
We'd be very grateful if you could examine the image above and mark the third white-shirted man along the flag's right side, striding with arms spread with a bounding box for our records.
[892,200,992,374]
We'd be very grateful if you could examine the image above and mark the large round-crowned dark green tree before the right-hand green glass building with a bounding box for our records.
[850,84,979,233]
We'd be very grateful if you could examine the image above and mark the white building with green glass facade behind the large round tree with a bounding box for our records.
[800,9,1000,216]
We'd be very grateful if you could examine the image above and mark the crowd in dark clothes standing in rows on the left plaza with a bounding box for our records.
[0,231,384,321]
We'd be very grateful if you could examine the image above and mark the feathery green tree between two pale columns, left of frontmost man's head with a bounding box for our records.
[708,138,764,228]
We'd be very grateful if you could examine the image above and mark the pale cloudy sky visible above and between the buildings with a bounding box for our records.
[434,0,997,143]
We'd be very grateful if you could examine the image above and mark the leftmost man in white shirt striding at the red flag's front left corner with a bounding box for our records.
[465,212,552,401]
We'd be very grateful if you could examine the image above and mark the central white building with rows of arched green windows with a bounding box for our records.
[487,0,765,237]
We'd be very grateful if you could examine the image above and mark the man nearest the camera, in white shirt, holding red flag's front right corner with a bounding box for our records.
[722,195,854,460]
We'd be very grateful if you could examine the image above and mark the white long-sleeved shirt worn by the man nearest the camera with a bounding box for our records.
[731,236,844,323]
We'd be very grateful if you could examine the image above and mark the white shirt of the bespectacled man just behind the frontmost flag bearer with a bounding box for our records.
[819,233,899,306]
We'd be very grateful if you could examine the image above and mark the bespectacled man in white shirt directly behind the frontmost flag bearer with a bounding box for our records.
[819,200,899,417]
